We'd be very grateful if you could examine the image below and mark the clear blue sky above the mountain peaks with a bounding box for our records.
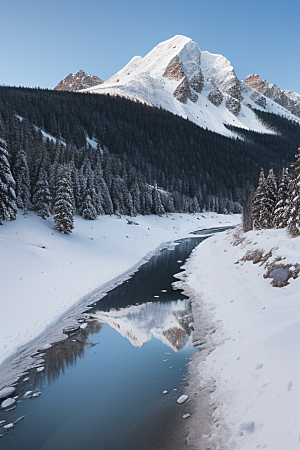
[0,0,300,93]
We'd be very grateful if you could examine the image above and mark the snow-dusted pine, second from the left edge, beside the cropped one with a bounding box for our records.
[14,150,31,214]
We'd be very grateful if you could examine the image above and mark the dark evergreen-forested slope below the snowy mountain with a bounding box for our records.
[0,86,300,229]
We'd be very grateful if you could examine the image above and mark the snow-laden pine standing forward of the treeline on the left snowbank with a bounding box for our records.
[53,164,74,234]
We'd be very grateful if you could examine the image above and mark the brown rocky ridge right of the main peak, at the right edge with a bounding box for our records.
[243,73,300,117]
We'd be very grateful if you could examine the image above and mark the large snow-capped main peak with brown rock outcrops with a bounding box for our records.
[79,36,299,135]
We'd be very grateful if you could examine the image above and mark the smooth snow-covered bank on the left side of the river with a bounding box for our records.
[0,212,239,388]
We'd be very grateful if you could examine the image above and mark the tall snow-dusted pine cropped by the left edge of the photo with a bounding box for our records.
[0,139,17,225]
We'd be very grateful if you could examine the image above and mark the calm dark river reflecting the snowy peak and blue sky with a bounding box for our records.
[0,230,229,450]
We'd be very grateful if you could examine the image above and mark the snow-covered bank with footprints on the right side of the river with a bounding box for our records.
[178,223,300,450]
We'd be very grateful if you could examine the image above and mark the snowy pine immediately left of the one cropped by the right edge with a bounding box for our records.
[274,168,291,228]
